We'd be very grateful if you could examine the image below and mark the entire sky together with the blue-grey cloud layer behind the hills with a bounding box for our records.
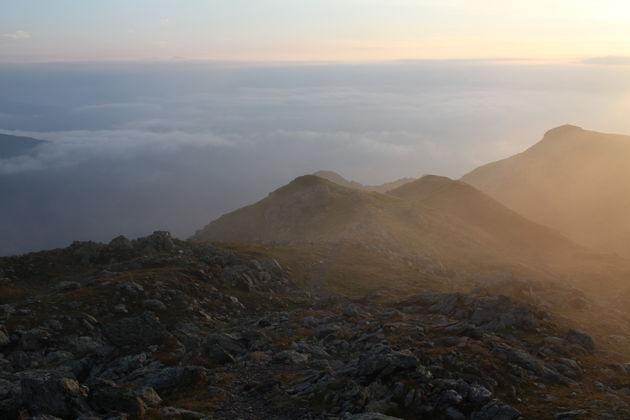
[0,0,630,255]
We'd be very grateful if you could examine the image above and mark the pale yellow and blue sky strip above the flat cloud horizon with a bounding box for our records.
[0,0,630,62]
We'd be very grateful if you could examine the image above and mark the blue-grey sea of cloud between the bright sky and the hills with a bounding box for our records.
[0,60,630,255]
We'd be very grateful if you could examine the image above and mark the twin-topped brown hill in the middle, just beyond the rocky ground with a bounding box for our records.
[194,175,582,265]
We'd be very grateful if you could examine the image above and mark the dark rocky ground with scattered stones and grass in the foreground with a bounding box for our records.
[0,232,630,420]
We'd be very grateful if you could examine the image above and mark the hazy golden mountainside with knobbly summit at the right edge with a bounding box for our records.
[462,126,630,255]
